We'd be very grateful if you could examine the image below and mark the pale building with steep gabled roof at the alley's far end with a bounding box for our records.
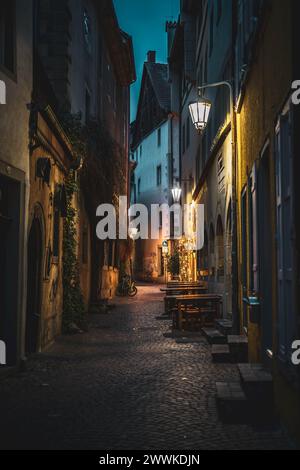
[131,51,179,280]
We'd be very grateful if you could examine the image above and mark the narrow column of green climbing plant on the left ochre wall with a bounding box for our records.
[63,171,86,333]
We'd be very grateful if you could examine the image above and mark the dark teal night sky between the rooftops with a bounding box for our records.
[114,0,180,120]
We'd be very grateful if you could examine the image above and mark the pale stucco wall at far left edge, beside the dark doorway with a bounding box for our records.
[0,0,33,364]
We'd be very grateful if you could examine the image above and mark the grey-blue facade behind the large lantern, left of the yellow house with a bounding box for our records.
[167,1,234,317]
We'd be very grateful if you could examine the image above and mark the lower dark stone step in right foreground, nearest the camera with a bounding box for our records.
[216,382,249,424]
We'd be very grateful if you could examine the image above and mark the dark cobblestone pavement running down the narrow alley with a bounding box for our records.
[0,286,289,450]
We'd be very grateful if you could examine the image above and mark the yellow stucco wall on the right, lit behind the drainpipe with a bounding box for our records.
[237,1,292,361]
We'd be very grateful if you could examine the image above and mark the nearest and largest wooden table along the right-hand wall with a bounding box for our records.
[173,294,222,330]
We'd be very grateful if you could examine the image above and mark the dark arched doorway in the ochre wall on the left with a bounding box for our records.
[25,217,43,354]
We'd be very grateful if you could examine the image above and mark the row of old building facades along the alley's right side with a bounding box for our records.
[167,0,300,438]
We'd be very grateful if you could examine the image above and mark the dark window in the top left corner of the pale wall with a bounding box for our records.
[0,0,16,73]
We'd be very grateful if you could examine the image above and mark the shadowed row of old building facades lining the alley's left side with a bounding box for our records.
[0,0,135,365]
